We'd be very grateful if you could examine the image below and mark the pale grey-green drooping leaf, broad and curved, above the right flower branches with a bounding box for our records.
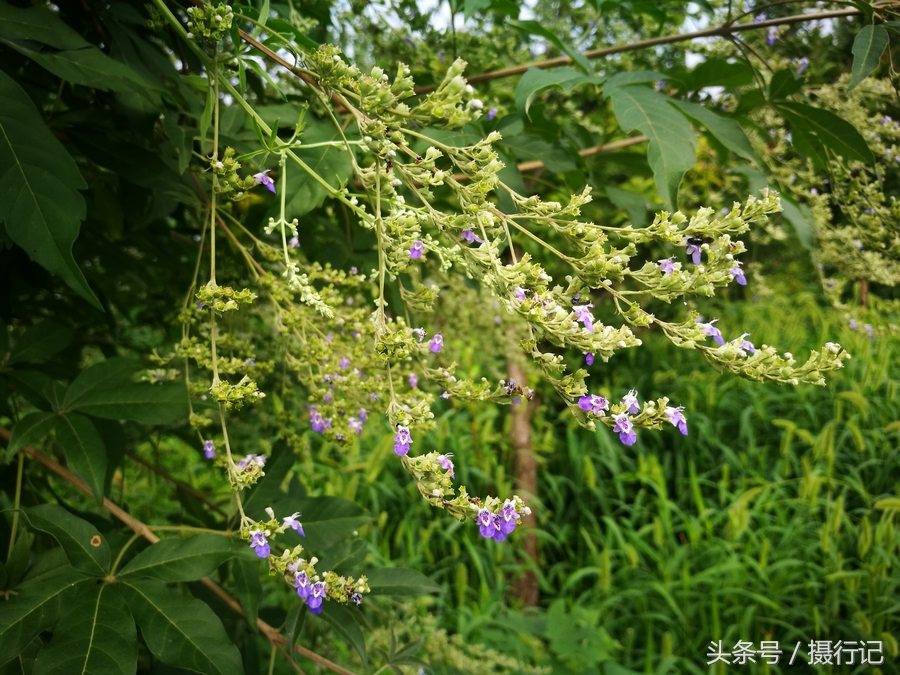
[606,86,697,211]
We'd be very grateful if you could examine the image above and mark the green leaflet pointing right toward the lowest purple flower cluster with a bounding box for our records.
[117,534,255,581]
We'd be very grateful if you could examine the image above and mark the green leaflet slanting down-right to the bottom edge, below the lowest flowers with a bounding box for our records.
[121,580,244,675]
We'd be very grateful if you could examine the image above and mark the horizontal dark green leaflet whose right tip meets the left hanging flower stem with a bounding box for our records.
[71,382,188,424]
